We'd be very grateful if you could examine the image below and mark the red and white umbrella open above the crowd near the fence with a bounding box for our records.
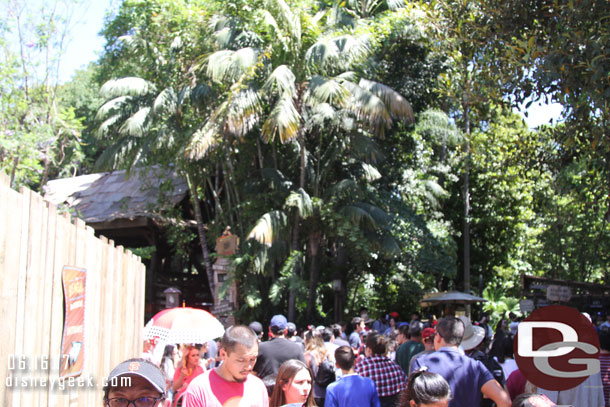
[144,307,225,343]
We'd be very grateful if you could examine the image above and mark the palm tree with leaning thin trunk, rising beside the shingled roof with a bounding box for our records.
[96,72,220,300]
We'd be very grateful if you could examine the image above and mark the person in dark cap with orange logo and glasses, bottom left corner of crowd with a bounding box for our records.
[104,359,166,407]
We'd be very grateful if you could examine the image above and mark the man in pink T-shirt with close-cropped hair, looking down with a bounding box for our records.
[183,325,269,407]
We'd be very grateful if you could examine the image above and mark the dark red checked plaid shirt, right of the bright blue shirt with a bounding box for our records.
[354,355,407,397]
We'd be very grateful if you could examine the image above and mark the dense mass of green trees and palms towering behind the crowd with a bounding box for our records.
[83,0,610,323]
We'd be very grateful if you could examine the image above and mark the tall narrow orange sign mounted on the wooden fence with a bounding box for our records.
[60,266,87,377]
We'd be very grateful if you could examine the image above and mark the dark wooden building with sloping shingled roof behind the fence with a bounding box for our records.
[45,167,213,319]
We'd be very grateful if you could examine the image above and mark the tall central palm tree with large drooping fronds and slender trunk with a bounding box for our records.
[188,0,413,319]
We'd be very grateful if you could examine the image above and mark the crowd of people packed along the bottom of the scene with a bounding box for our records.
[104,313,610,407]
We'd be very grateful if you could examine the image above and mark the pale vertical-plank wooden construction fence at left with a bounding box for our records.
[0,172,146,407]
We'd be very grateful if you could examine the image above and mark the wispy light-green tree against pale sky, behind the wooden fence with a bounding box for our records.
[0,0,84,189]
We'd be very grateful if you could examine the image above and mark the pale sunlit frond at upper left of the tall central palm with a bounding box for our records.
[205,47,258,83]
